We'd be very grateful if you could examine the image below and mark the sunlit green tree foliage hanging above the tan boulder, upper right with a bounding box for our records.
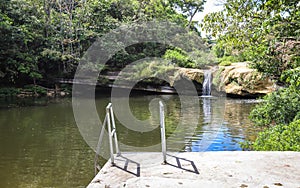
[202,0,300,79]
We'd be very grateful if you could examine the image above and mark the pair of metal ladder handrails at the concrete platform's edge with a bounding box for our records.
[94,101,167,174]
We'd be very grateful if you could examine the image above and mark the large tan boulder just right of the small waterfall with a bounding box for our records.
[214,62,275,97]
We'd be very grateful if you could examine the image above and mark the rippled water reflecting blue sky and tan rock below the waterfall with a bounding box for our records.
[185,97,259,152]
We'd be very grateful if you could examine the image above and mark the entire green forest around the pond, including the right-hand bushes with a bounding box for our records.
[0,0,300,151]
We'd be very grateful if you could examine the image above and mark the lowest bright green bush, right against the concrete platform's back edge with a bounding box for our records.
[253,120,300,151]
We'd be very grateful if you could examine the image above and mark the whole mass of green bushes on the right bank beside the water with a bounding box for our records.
[244,65,300,151]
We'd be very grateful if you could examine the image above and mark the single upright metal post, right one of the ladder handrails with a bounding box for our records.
[159,101,167,164]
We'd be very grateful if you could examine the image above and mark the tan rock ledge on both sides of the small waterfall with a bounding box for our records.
[103,62,275,97]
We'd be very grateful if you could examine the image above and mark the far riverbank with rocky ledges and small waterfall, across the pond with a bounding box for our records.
[0,62,277,98]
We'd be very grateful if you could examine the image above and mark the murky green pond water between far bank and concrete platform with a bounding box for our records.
[0,95,257,188]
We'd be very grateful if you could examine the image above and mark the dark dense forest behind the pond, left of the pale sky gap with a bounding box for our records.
[0,0,210,86]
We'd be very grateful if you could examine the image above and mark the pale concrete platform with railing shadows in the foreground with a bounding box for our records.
[88,151,300,188]
